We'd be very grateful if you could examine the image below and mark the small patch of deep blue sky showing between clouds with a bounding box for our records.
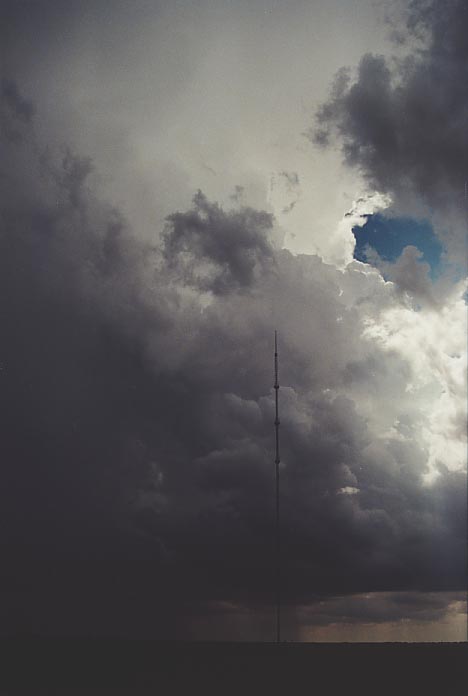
[353,213,443,280]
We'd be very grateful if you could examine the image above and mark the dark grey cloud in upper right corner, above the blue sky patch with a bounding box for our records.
[311,0,468,252]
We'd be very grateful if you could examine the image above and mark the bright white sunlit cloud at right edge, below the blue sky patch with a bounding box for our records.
[365,296,467,479]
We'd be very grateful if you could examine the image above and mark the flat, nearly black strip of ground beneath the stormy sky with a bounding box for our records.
[0,639,468,696]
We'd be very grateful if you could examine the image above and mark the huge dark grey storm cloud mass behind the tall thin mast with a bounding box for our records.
[0,75,466,637]
